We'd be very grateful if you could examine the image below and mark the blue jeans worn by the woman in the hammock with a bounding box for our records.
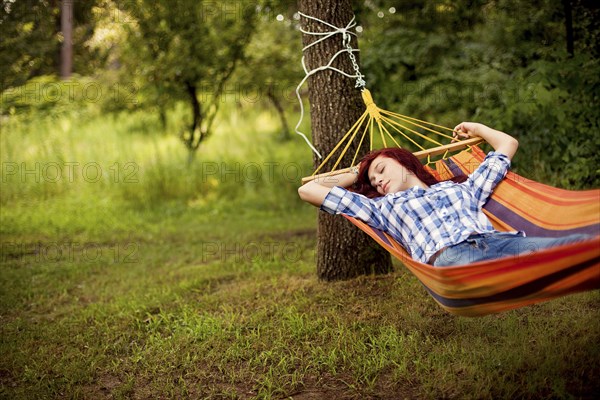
[433,232,592,267]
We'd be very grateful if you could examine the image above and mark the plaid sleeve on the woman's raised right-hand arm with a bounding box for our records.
[463,151,510,207]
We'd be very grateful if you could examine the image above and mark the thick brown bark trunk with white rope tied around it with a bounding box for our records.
[298,0,392,280]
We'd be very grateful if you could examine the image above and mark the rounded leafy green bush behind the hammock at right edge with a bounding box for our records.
[474,55,600,189]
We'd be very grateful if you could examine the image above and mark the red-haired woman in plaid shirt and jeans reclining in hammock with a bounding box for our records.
[298,122,588,266]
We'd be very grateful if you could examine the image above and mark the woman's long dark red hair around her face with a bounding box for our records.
[353,147,467,198]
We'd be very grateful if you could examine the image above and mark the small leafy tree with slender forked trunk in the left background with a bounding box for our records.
[124,0,256,161]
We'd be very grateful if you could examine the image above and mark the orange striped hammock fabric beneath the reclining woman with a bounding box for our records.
[346,146,600,317]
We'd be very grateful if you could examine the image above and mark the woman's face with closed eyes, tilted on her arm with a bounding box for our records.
[367,155,412,196]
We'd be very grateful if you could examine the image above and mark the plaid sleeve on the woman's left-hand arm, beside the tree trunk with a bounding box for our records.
[320,186,384,229]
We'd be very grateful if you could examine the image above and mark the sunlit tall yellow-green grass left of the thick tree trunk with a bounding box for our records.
[0,104,310,241]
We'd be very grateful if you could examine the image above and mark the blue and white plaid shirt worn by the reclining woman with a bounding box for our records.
[321,151,510,263]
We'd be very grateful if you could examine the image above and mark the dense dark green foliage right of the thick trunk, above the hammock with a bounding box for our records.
[361,0,600,188]
